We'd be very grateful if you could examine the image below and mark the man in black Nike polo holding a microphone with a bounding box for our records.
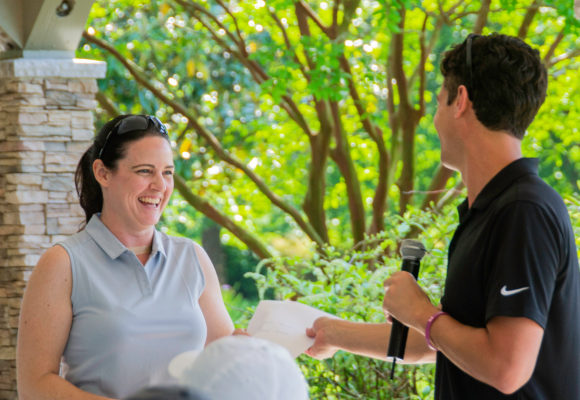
[307,34,580,400]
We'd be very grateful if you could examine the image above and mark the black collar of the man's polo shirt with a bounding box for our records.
[457,158,539,220]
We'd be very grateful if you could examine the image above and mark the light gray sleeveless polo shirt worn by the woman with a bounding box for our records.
[59,215,207,398]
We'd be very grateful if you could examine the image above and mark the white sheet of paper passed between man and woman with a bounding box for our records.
[247,300,336,357]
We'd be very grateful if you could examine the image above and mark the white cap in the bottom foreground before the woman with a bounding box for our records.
[179,335,308,400]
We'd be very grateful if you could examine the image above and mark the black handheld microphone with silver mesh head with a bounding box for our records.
[387,239,425,379]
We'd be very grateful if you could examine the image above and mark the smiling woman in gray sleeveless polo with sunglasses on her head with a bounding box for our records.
[17,115,234,400]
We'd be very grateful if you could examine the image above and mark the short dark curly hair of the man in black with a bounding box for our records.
[441,33,548,139]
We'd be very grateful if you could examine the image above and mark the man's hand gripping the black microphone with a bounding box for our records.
[383,271,437,333]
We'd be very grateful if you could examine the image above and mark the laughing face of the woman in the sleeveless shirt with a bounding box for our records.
[99,136,174,229]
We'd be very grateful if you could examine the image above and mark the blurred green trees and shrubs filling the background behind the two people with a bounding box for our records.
[77,0,580,399]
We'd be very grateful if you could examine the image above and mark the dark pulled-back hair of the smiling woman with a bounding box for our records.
[75,114,169,223]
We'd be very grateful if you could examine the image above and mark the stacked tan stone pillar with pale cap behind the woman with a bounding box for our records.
[0,58,106,399]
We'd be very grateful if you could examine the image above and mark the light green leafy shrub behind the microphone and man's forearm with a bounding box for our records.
[247,207,457,399]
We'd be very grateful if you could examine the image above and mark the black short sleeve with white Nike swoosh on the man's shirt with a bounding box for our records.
[485,202,561,328]
